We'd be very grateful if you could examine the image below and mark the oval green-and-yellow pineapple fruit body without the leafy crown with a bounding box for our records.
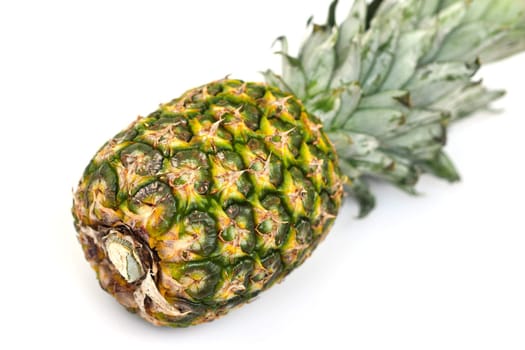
[72,79,345,327]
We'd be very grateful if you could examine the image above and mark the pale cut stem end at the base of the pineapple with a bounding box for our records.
[105,231,144,283]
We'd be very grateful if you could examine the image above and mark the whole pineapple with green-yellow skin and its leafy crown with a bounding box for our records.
[73,0,525,327]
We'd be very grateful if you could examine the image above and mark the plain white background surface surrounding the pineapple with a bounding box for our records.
[0,0,525,350]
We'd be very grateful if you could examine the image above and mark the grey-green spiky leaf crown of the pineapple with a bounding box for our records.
[263,0,525,217]
